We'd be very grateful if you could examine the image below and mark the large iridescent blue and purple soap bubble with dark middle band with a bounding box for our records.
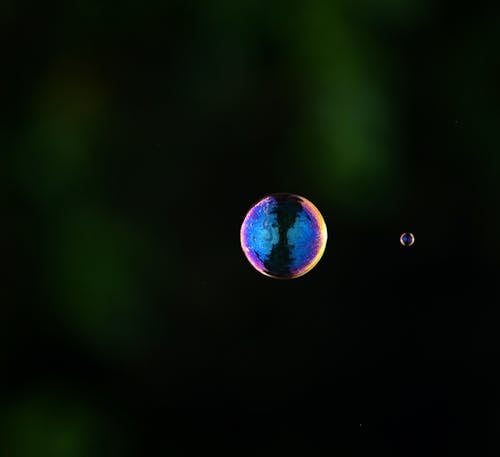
[240,193,327,279]
